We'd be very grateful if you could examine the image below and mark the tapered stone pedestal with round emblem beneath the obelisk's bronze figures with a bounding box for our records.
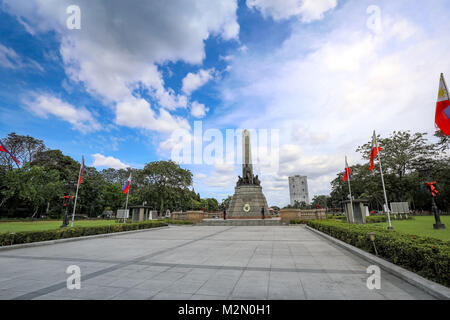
[227,185,269,219]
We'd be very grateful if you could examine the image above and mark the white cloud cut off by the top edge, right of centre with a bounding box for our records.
[246,0,337,22]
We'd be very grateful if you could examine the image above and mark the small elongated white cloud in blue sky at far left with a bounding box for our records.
[24,94,101,132]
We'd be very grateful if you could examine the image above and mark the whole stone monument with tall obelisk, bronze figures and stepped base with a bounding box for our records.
[227,130,269,219]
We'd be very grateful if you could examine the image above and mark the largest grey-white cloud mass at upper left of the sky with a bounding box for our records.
[2,0,239,136]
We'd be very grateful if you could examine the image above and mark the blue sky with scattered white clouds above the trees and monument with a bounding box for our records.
[0,0,450,205]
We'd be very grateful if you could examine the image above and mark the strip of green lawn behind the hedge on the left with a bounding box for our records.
[0,220,116,233]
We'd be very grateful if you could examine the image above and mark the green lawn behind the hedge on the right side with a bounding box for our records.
[373,216,450,241]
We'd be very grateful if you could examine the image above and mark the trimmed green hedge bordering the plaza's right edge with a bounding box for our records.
[308,220,450,287]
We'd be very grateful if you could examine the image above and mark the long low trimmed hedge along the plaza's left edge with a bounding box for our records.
[0,221,167,246]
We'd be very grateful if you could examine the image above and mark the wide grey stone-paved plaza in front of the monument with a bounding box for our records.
[0,226,432,300]
